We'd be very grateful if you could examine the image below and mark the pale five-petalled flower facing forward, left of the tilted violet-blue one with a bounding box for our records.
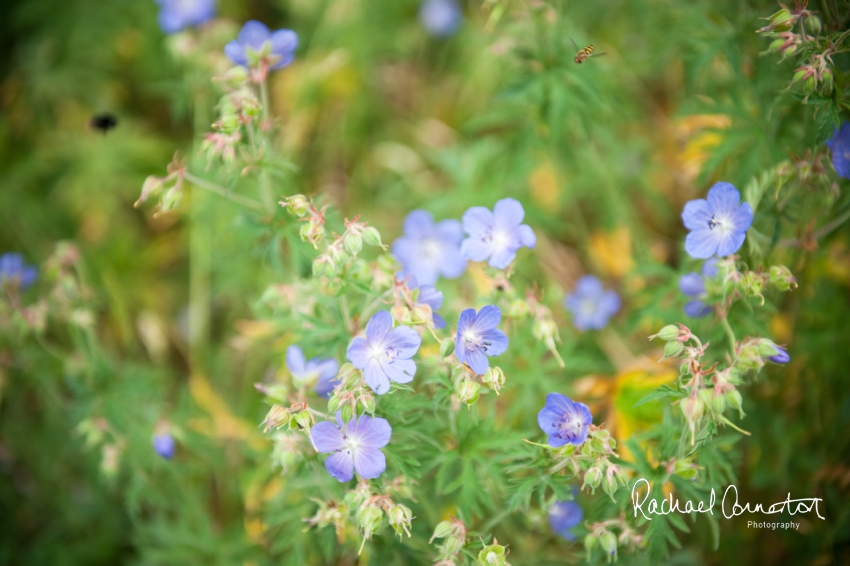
[346,311,422,395]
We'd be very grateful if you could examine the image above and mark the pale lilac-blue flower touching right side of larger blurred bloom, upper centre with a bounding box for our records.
[460,198,537,269]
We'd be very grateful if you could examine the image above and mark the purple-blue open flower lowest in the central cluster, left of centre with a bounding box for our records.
[310,413,393,482]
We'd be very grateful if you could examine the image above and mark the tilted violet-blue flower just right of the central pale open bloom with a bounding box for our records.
[455,305,508,375]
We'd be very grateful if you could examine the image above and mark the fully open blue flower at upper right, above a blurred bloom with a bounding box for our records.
[682,183,753,259]
